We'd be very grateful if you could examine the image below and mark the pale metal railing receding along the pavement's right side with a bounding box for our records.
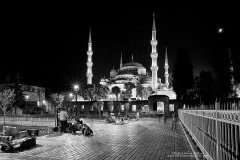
[178,100,240,160]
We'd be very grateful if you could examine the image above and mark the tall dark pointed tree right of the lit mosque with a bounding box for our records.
[172,47,194,103]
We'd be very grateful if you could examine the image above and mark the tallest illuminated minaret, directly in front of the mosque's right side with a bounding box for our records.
[151,14,158,91]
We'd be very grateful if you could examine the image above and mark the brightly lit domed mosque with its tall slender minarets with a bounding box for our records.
[86,15,176,100]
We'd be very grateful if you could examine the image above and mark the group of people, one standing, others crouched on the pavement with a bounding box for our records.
[59,108,93,135]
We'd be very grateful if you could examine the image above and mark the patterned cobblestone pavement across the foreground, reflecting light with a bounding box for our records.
[0,118,195,160]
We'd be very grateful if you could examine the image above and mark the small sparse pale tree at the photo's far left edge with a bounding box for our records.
[0,89,15,126]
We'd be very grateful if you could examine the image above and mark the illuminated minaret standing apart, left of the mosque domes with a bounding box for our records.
[86,28,93,84]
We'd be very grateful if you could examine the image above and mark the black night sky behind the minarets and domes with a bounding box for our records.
[0,4,240,92]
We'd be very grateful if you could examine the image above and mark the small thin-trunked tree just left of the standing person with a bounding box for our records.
[50,93,64,126]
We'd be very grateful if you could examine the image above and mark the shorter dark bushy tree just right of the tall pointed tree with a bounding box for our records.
[196,71,216,105]
